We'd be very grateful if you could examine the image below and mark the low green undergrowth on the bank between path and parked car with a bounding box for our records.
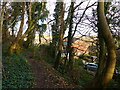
[54,59,94,87]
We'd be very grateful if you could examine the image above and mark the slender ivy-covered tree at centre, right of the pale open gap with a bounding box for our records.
[51,2,61,59]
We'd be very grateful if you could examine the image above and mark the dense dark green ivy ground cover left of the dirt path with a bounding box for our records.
[2,54,34,88]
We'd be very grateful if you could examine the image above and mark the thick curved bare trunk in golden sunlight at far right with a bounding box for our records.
[92,0,116,88]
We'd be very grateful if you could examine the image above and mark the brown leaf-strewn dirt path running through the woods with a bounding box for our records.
[26,57,74,88]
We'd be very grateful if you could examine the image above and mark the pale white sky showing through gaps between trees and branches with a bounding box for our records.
[9,0,117,37]
